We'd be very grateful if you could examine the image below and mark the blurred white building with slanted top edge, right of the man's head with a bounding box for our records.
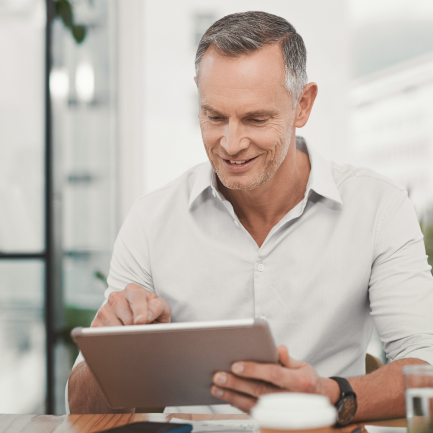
[350,53,433,218]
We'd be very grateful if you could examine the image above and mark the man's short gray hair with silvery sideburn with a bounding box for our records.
[195,12,308,106]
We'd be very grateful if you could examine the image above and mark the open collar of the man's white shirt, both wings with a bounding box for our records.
[188,137,343,207]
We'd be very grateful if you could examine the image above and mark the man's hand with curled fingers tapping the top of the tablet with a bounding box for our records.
[91,283,171,327]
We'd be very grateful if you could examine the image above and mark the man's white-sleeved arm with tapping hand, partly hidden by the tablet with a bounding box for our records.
[66,202,171,413]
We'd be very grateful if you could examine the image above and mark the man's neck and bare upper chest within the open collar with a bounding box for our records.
[217,137,310,246]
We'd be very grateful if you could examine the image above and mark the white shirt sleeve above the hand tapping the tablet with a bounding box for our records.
[104,202,155,303]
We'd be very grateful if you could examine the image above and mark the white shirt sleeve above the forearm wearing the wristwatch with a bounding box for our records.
[369,191,433,365]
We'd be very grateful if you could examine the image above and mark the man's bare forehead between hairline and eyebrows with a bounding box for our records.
[199,44,290,109]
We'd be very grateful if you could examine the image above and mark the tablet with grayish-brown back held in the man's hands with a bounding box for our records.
[71,319,278,408]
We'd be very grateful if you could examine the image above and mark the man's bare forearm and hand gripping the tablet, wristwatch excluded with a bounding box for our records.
[211,346,426,421]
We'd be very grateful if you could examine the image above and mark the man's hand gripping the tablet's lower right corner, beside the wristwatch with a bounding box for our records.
[211,346,339,413]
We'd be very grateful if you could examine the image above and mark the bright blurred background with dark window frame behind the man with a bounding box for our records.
[0,0,433,414]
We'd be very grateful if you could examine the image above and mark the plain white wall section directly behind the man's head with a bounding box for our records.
[141,0,348,192]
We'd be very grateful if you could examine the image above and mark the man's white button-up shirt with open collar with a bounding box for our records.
[66,139,433,411]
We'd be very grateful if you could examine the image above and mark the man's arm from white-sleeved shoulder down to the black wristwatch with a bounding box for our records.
[340,191,433,420]
